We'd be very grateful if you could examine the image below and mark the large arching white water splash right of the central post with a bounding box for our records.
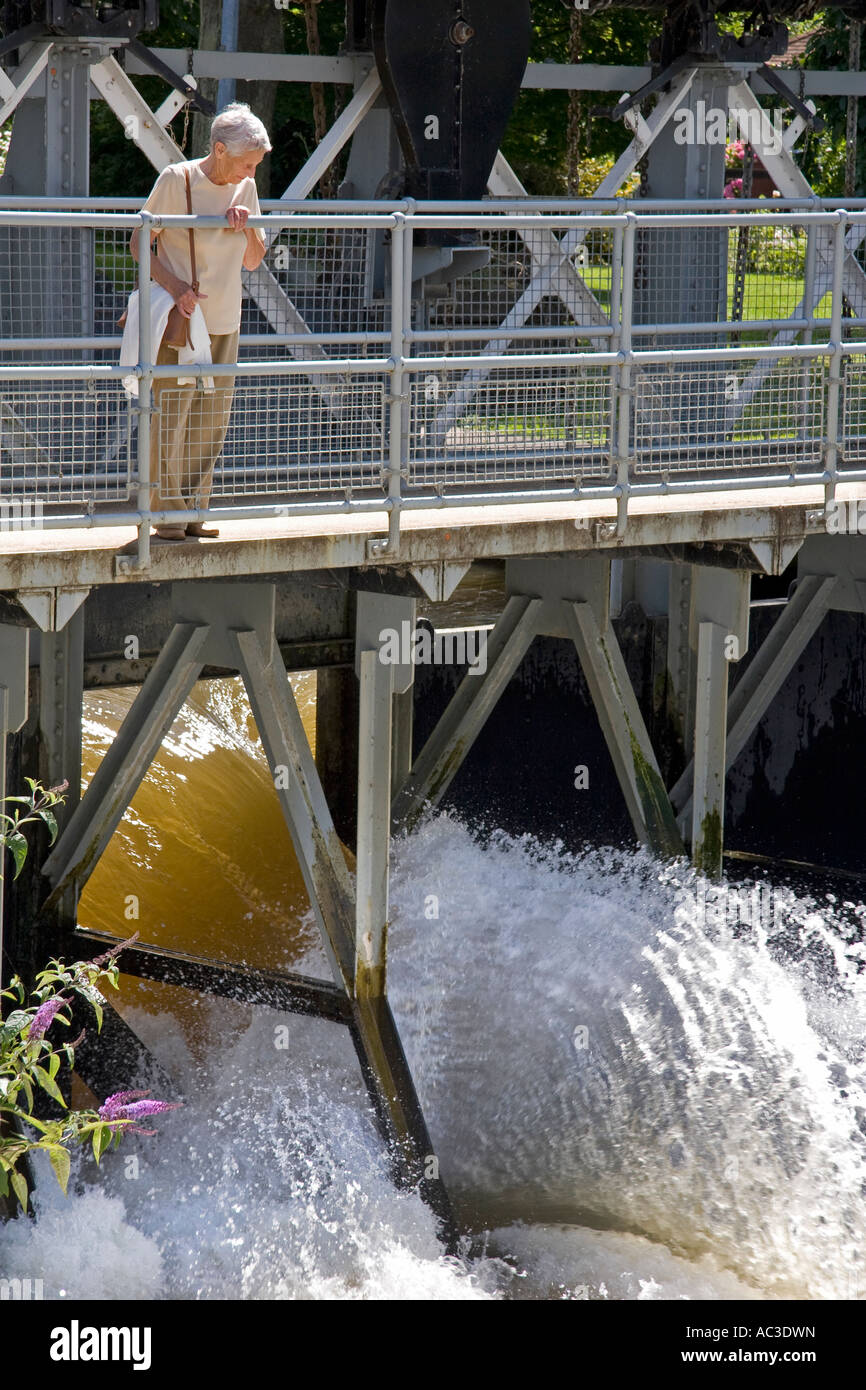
[391,817,866,1298]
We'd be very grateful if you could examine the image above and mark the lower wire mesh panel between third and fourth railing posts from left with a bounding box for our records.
[632,357,826,473]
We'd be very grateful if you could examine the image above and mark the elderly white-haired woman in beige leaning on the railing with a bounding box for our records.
[131,101,271,541]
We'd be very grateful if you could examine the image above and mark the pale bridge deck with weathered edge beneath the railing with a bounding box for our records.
[0,482,866,589]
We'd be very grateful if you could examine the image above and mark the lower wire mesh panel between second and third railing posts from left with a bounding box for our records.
[409,367,610,489]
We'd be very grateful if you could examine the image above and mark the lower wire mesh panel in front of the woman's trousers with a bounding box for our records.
[152,374,385,502]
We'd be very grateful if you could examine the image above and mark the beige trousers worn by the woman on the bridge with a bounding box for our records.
[150,332,238,512]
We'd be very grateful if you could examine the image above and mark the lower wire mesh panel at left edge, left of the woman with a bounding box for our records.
[0,381,135,506]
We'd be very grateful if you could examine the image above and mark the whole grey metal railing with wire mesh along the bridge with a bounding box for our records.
[0,199,866,566]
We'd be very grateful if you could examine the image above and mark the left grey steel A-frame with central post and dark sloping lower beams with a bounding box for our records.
[38,584,456,1251]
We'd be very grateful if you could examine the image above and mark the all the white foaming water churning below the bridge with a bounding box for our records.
[0,816,866,1300]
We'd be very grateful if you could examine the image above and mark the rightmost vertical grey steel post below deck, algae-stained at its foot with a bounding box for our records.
[692,623,728,878]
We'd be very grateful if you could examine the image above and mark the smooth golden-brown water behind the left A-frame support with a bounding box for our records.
[79,673,323,1031]
